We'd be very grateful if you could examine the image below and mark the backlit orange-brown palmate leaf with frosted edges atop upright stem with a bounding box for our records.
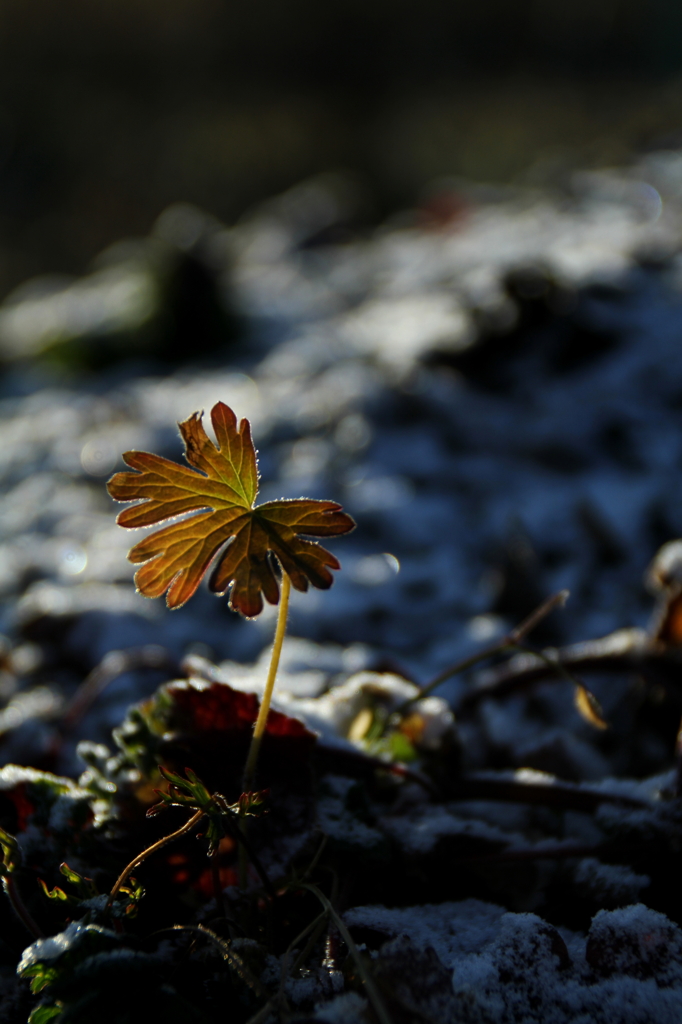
[108,401,355,617]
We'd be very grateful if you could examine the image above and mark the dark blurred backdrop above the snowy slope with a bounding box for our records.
[0,0,682,296]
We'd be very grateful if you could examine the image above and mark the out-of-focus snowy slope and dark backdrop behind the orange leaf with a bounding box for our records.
[5,0,682,778]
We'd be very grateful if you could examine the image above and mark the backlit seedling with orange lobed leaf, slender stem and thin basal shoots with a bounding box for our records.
[81,402,390,1024]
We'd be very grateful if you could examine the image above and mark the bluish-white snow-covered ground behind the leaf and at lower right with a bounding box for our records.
[0,153,682,1024]
